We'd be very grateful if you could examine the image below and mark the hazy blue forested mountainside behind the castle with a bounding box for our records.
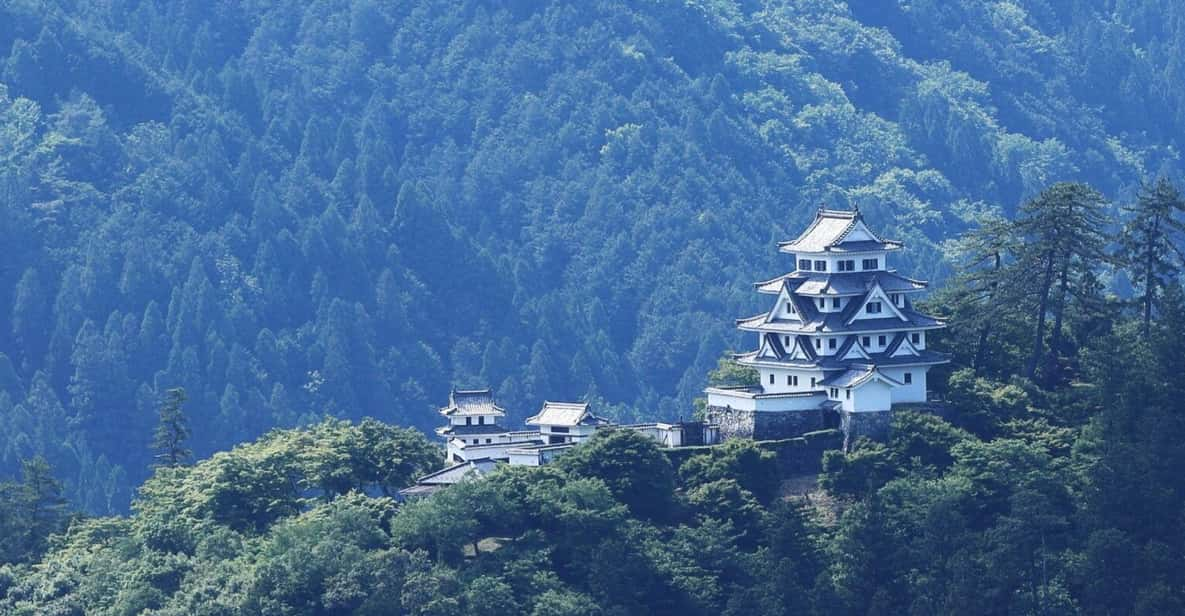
[0,0,1185,513]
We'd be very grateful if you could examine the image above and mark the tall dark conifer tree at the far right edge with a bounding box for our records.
[1121,178,1185,338]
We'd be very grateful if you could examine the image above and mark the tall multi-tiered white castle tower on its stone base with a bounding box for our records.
[706,208,948,438]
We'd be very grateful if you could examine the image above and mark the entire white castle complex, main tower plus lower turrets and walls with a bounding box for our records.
[402,208,948,496]
